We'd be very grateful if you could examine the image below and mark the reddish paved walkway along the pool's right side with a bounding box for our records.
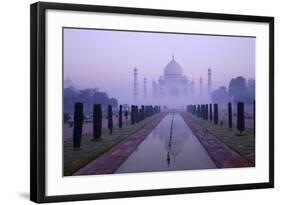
[181,112,254,168]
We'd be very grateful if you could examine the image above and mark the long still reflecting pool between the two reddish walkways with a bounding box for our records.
[115,113,216,173]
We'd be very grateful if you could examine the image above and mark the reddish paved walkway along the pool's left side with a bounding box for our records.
[73,113,166,176]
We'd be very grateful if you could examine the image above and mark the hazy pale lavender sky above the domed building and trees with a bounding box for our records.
[64,29,255,104]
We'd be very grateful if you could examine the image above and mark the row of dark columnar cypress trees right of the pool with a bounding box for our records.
[186,102,255,134]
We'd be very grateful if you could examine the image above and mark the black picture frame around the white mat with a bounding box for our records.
[30,2,274,203]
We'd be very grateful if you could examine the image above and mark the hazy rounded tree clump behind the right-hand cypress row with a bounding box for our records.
[211,76,255,105]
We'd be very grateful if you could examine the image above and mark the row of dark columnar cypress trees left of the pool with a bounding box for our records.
[73,102,161,148]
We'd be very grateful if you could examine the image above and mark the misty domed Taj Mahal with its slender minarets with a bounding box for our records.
[133,55,212,106]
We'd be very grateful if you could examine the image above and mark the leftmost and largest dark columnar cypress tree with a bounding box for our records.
[73,102,83,148]
